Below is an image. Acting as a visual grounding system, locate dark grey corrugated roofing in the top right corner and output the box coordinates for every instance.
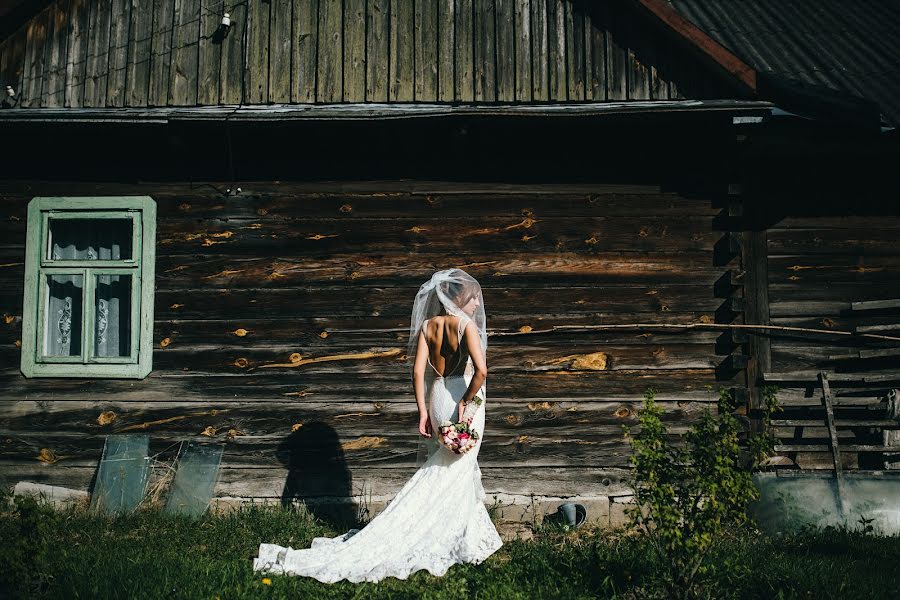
[668,0,900,126]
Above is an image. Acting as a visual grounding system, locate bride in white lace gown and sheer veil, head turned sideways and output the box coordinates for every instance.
[253,269,502,583]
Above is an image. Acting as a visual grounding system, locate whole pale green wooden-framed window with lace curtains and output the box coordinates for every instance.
[22,196,156,378]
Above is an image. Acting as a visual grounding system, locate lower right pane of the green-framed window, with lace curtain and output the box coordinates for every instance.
[94,275,131,357]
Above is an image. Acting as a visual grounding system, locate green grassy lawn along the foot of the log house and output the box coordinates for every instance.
[0,496,900,600]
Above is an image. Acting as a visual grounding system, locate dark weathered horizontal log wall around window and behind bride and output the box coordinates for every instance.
[0,182,732,497]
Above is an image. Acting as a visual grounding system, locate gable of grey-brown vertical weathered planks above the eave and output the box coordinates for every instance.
[0,0,734,108]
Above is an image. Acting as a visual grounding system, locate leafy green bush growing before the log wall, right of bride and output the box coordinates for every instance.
[627,390,776,598]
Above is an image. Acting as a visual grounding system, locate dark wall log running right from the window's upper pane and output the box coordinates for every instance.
[151,217,715,257]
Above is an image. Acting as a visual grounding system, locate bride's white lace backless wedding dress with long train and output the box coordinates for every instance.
[253,320,502,583]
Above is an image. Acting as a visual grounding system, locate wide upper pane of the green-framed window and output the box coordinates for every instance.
[48,219,132,260]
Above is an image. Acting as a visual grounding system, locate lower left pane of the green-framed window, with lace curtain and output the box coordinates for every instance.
[44,275,84,356]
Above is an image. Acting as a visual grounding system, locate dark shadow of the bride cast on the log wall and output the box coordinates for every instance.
[276,421,358,530]
